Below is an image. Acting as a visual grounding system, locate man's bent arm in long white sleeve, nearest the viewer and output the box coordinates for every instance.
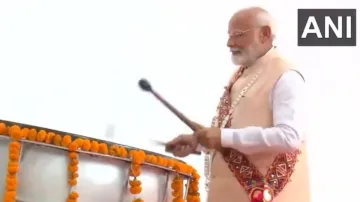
[221,71,305,154]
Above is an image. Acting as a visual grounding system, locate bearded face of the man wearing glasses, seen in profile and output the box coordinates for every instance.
[227,16,261,65]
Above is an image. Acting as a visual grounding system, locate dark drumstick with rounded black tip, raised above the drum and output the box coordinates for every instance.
[139,79,201,155]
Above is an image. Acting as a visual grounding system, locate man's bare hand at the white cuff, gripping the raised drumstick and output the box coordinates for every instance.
[194,127,221,150]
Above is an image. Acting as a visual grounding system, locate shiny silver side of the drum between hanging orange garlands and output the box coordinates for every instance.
[0,121,190,202]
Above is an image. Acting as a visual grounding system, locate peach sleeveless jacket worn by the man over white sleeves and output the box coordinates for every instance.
[208,50,310,202]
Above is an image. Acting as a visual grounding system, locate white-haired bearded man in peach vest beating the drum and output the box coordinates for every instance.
[166,8,310,202]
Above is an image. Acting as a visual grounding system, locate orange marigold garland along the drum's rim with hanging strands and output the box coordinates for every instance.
[0,123,200,202]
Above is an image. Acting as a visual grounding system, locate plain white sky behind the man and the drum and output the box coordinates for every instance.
[0,0,360,202]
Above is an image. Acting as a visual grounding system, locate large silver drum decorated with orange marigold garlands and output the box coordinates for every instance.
[0,120,200,202]
